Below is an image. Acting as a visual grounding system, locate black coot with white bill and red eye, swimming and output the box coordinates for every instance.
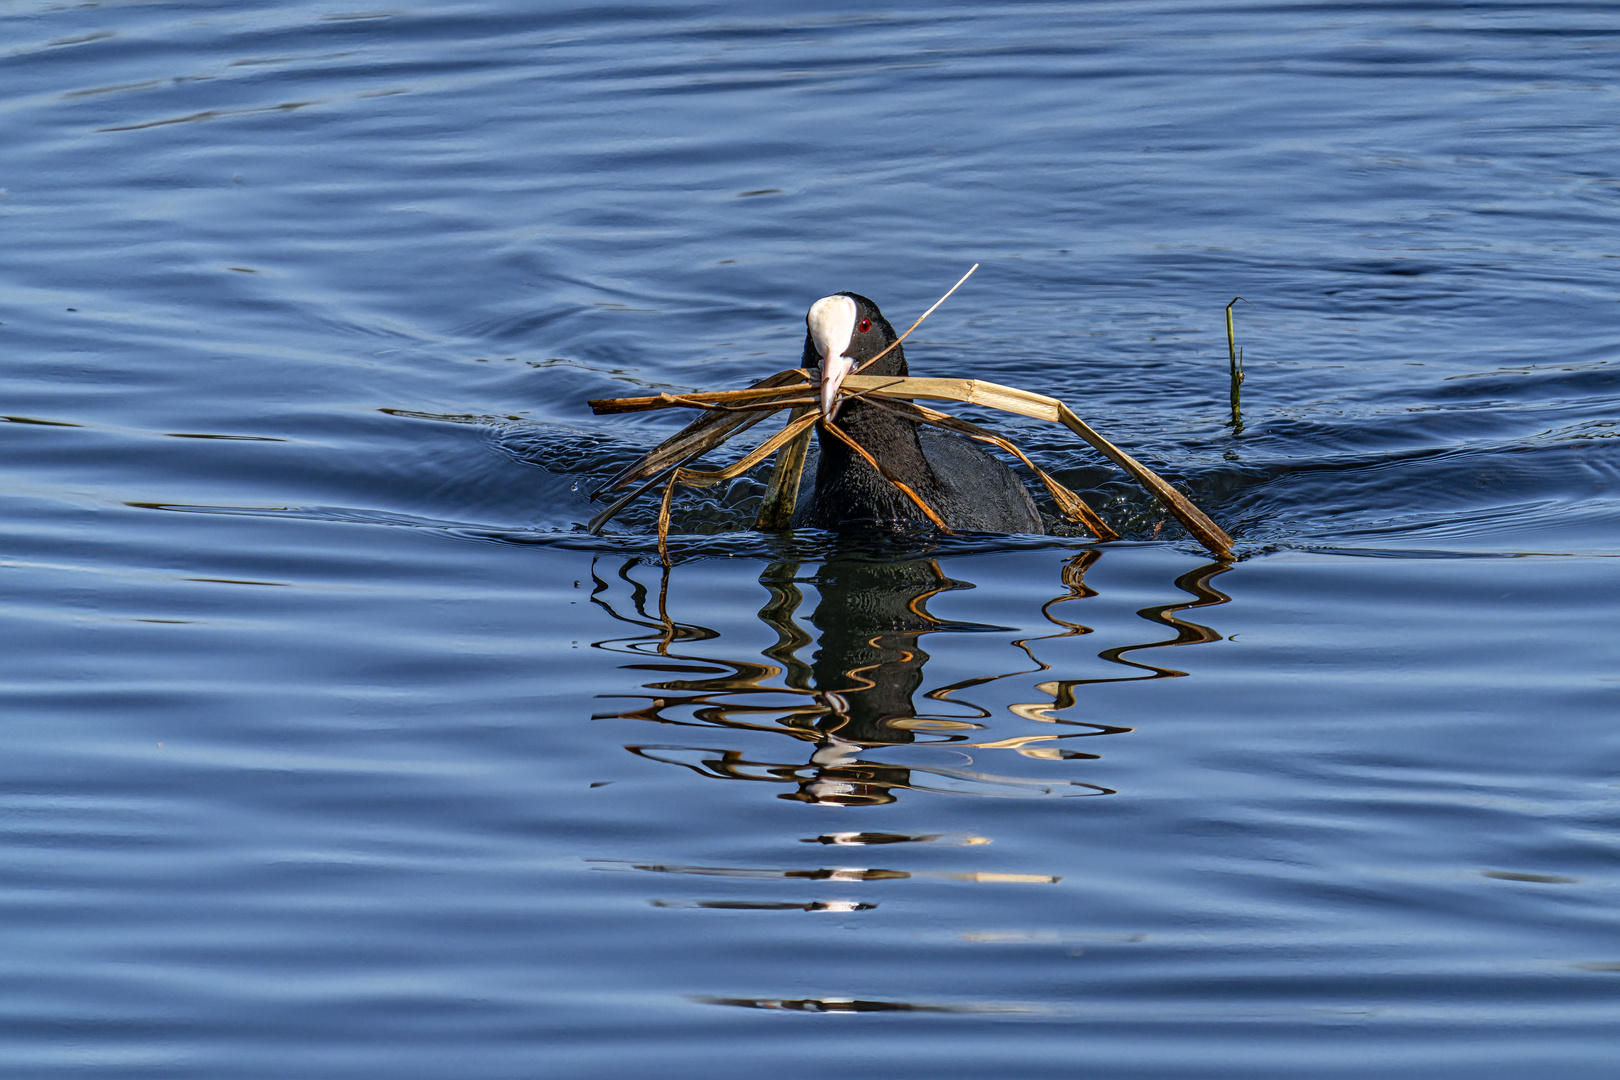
[792,293,1047,533]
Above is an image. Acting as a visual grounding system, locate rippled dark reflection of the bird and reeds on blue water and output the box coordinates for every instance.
[591,549,1230,803]
